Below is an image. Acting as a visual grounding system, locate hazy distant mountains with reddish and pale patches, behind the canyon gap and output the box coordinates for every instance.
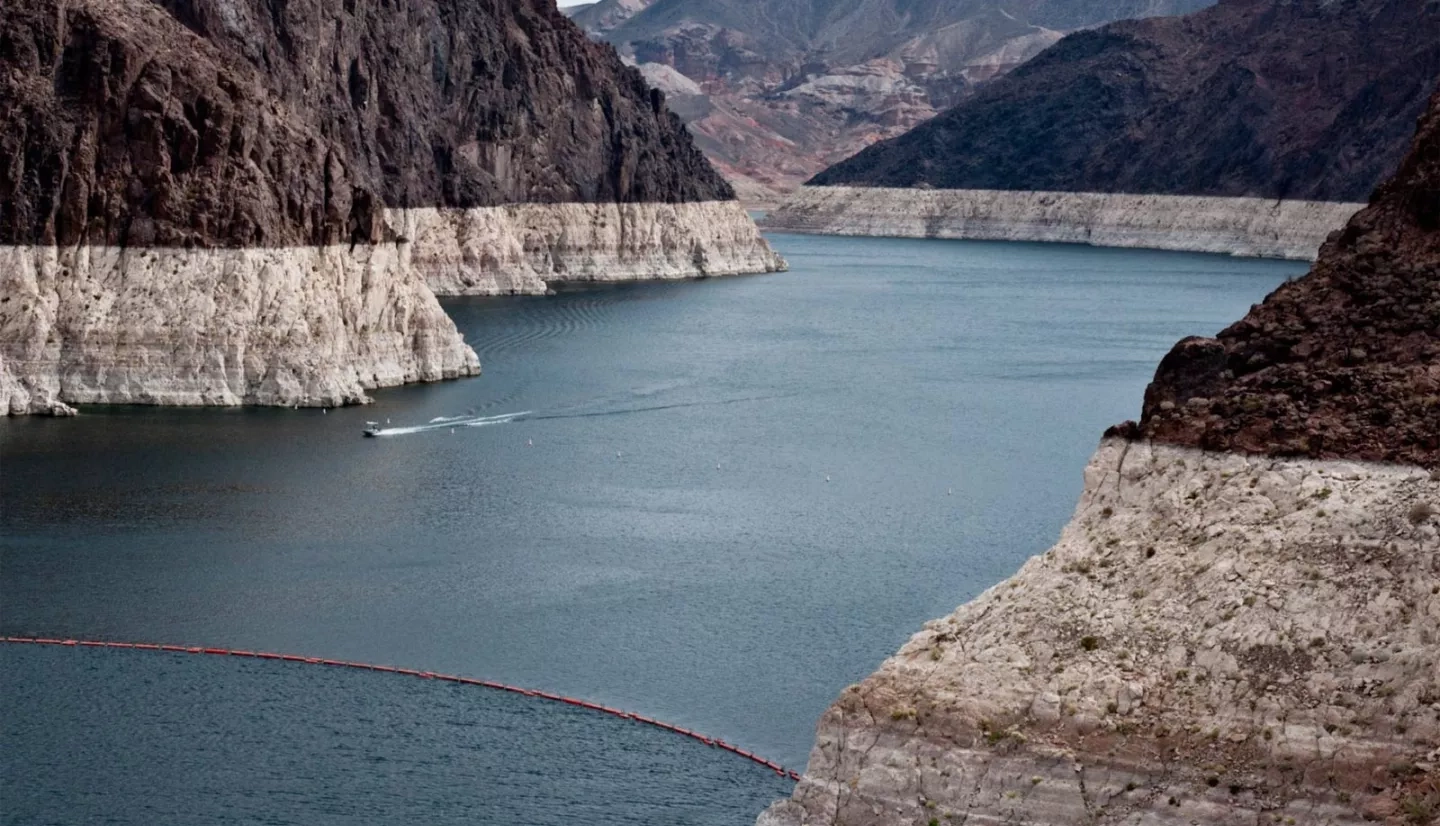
[576,0,1210,201]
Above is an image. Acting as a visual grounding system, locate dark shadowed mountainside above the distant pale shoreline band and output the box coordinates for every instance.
[812,0,1440,201]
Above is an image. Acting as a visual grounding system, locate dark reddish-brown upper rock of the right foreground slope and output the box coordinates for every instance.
[1126,84,1440,468]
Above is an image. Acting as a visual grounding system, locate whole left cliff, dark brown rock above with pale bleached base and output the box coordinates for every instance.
[0,0,783,413]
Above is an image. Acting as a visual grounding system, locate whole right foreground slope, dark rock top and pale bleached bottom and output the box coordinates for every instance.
[760,92,1440,826]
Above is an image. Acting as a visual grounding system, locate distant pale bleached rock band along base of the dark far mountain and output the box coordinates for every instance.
[765,187,1364,260]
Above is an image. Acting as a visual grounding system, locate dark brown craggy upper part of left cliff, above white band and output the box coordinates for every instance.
[0,0,732,246]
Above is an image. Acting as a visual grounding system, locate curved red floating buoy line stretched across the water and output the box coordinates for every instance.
[0,636,801,780]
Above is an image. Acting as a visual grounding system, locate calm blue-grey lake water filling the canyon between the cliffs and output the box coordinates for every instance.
[0,236,1305,825]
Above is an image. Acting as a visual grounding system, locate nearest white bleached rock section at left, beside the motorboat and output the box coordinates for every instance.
[0,245,480,414]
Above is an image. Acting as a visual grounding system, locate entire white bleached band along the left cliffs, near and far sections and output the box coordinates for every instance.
[0,201,785,414]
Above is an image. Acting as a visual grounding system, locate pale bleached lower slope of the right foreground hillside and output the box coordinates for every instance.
[760,439,1440,826]
